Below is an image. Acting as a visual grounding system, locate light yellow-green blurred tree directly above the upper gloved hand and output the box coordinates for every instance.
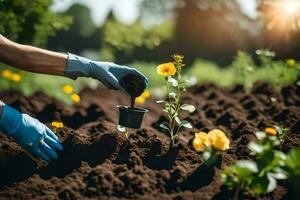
[101,13,174,63]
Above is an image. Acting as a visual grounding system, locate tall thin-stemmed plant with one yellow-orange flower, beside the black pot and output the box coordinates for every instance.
[157,55,195,144]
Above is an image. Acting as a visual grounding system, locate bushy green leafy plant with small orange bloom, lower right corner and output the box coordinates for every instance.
[222,129,287,199]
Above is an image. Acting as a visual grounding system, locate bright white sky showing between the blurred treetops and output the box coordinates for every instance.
[52,0,258,25]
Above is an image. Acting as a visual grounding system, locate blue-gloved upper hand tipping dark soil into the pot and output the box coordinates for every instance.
[65,53,148,95]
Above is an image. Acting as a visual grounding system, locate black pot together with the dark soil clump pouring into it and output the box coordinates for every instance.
[117,74,148,133]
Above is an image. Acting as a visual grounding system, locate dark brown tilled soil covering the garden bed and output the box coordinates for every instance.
[0,84,300,199]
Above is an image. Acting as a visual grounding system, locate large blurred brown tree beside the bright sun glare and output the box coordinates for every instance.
[175,0,260,65]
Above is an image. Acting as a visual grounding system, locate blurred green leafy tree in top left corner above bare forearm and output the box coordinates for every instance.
[0,0,72,45]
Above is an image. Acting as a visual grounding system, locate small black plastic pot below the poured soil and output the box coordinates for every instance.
[117,105,148,129]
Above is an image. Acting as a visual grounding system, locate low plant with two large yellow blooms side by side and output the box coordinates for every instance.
[193,129,230,165]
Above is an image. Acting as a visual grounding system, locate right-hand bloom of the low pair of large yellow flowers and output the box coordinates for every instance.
[208,129,230,151]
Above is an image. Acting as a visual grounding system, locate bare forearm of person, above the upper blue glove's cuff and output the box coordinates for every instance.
[0,35,68,76]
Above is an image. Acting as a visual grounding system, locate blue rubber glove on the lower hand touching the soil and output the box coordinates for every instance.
[0,105,63,160]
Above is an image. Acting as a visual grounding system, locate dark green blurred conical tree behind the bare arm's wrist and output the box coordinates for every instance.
[48,4,102,54]
